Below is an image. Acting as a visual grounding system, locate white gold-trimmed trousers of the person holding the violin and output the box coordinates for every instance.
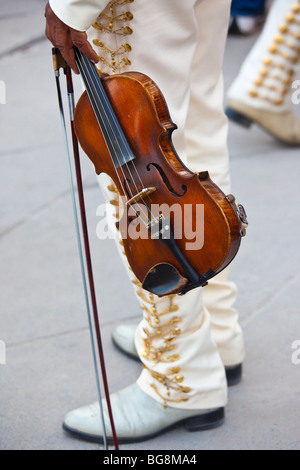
[85,0,244,409]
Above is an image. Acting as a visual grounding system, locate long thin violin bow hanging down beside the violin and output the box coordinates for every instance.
[52,48,119,450]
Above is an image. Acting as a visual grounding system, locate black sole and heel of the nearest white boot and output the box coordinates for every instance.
[62,408,225,445]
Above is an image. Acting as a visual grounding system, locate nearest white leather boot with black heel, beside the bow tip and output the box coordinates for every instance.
[63,384,225,444]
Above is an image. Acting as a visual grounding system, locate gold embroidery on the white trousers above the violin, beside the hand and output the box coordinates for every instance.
[93,0,134,74]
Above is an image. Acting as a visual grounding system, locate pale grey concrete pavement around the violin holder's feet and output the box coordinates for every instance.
[0,0,300,450]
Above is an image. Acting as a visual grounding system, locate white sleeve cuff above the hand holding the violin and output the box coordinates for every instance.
[49,0,108,31]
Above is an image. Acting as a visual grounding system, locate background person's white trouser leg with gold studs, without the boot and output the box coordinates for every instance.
[228,0,300,112]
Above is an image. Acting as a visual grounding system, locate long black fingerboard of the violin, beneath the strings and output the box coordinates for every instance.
[74,47,135,169]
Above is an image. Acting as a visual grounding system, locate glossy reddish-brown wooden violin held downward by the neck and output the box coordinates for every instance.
[74,48,248,297]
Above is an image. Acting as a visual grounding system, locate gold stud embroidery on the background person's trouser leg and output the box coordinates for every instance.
[249,0,300,106]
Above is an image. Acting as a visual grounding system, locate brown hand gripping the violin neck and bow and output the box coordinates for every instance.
[45,2,99,74]
